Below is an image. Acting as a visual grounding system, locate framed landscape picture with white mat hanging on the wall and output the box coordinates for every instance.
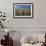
[13,3,33,17]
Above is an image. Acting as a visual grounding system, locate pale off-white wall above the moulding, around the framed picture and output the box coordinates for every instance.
[0,0,46,27]
